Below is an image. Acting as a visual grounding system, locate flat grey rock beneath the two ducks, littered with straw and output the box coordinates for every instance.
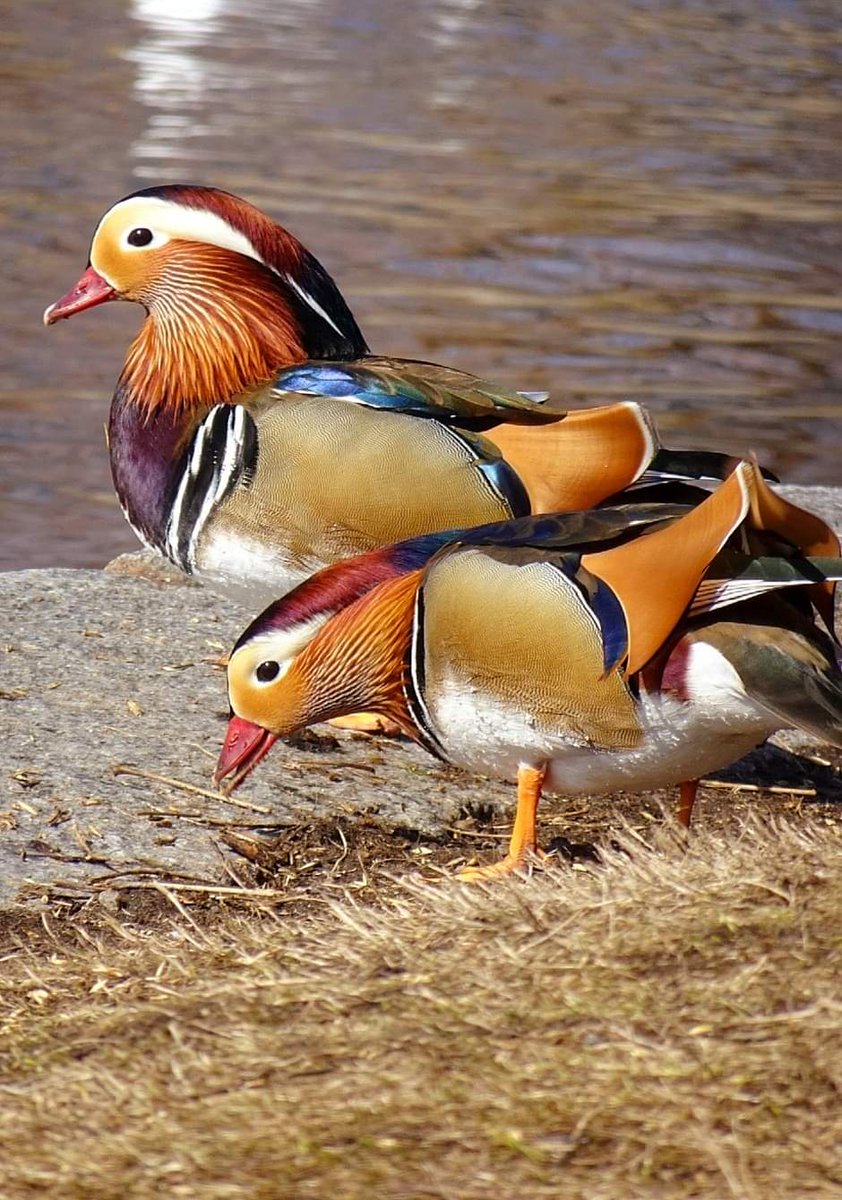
[0,488,842,906]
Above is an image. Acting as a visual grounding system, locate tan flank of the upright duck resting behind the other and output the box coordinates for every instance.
[206,392,529,570]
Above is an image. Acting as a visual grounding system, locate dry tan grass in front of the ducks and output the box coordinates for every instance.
[0,823,842,1200]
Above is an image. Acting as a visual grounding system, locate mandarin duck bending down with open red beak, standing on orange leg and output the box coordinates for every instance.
[215,463,842,880]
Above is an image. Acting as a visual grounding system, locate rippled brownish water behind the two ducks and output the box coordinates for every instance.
[0,0,842,566]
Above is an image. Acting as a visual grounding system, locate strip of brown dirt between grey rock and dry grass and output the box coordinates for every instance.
[0,738,842,950]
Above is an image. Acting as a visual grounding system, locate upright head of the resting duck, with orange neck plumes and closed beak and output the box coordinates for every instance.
[43,184,368,408]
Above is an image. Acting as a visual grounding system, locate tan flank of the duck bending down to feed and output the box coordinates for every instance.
[415,545,642,757]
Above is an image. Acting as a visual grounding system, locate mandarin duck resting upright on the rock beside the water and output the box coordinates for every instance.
[44,185,743,604]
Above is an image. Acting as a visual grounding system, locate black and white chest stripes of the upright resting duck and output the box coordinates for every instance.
[163,404,258,574]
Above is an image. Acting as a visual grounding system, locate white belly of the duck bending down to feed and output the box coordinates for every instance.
[427,643,781,797]
